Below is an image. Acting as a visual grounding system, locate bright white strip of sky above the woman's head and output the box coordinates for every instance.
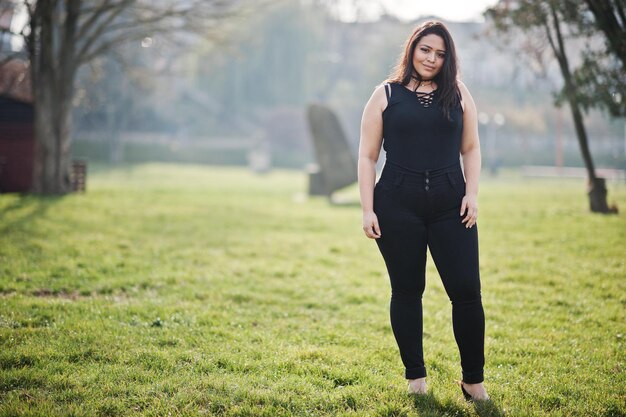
[337,0,497,21]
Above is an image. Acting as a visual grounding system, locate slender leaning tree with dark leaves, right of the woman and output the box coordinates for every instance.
[485,0,626,213]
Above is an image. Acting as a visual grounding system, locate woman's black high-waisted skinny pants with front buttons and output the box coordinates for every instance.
[374,163,485,384]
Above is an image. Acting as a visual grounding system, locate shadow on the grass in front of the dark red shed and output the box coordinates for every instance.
[0,194,64,234]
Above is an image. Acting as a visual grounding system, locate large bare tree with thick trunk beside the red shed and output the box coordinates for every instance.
[2,0,265,194]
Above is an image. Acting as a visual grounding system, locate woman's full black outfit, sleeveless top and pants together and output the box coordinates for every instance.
[374,84,485,383]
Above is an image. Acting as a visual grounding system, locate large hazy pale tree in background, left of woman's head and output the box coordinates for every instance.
[185,0,400,156]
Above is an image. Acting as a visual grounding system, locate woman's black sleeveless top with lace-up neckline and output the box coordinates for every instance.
[383,83,463,171]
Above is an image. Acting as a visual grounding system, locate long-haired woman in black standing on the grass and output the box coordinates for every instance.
[358,21,489,400]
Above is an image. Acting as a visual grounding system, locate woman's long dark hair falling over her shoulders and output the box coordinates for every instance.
[385,20,461,119]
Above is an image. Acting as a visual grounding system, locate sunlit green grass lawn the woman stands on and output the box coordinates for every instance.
[0,164,626,417]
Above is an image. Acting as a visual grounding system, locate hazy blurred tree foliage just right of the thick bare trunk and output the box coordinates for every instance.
[72,36,176,164]
